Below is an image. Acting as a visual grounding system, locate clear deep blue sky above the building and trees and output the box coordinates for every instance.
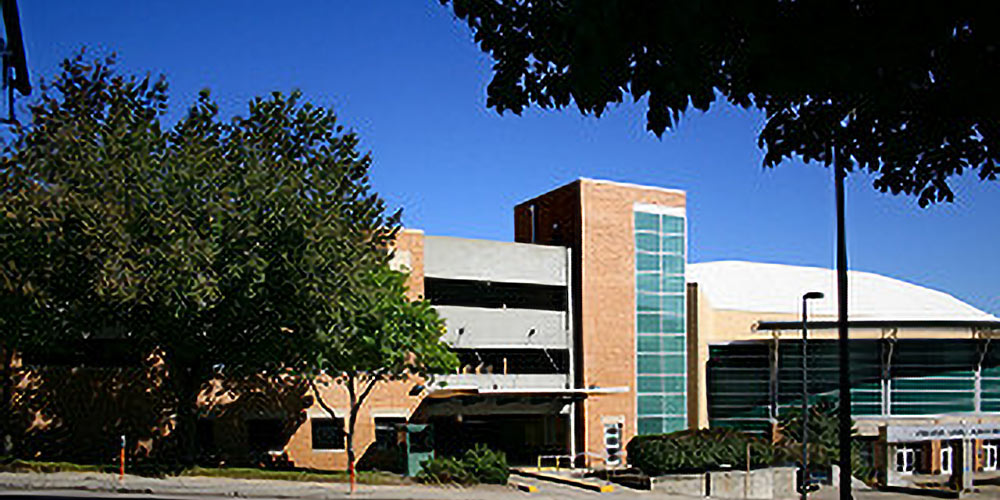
[20,0,1000,315]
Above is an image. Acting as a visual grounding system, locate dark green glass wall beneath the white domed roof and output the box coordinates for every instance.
[708,339,1000,432]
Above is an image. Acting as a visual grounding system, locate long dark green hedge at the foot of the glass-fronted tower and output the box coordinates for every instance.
[626,429,783,476]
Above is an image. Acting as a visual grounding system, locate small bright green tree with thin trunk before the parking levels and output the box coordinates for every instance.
[304,266,458,491]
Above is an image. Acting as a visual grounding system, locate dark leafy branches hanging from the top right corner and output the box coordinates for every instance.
[441,0,1000,206]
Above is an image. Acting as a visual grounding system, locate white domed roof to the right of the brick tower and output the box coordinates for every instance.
[687,261,1000,321]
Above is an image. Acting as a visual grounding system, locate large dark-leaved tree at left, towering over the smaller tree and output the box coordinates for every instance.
[0,53,399,463]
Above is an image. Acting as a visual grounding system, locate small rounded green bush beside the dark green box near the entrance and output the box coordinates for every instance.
[417,445,510,485]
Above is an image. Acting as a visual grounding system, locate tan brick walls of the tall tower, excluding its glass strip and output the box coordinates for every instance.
[514,179,685,464]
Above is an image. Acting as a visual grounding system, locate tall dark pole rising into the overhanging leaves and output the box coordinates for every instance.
[833,154,853,500]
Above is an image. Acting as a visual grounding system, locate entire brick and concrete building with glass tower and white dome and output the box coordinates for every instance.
[11,179,1000,472]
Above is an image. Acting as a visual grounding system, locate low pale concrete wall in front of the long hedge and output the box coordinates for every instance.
[651,467,798,500]
